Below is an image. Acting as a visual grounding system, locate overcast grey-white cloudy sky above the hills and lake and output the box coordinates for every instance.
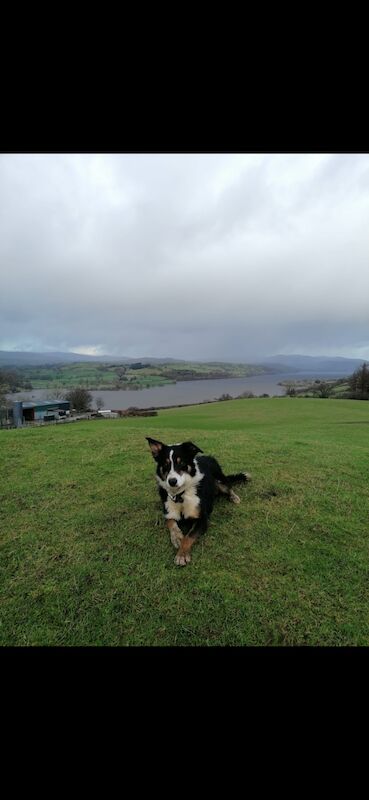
[0,154,369,361]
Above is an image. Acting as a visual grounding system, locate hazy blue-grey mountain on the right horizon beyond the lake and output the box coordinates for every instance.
[261,355,364,375]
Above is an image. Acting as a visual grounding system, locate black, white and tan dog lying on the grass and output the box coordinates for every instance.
[146,436,251,567]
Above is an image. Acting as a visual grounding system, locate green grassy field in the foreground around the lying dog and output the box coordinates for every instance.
[0,398,369,646]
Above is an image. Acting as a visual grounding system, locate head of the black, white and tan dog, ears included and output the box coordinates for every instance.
[146,436,203,495]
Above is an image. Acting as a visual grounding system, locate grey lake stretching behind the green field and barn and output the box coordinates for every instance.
[8,372,346,409]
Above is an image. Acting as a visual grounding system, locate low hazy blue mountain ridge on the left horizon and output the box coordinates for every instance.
[0,350,183,367]
